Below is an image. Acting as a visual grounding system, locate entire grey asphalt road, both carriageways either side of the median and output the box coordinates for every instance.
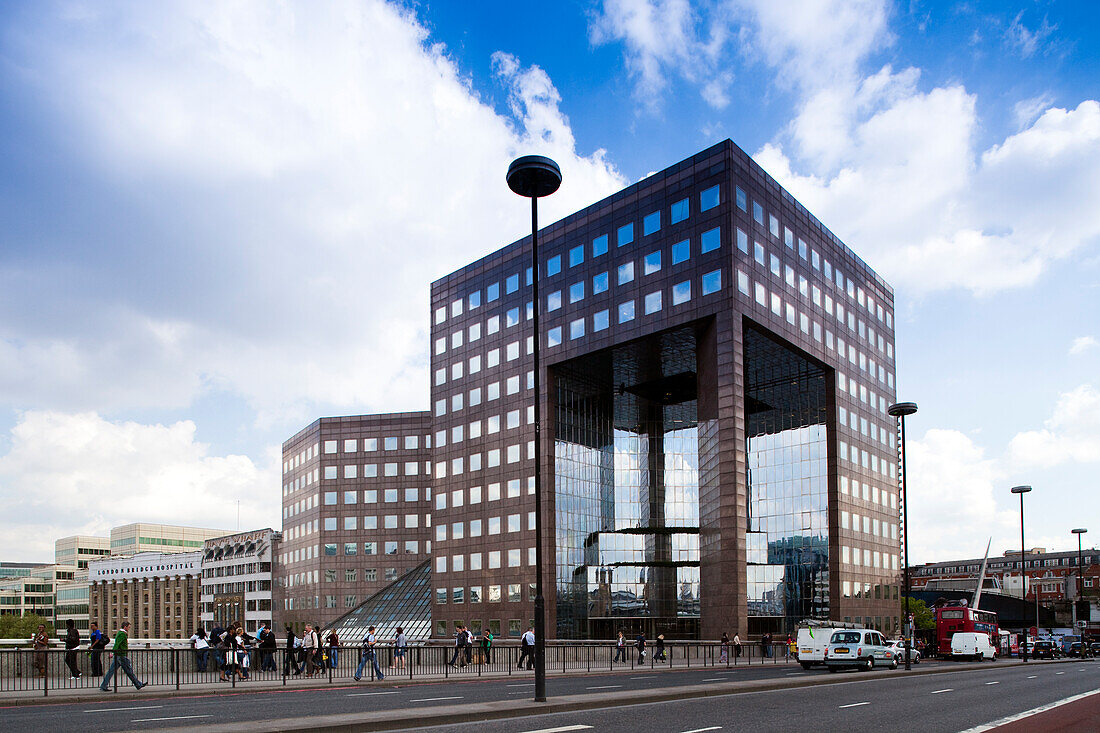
[0,661,1100,733]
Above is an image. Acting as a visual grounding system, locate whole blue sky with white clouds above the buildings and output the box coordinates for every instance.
[0,0,1100,561]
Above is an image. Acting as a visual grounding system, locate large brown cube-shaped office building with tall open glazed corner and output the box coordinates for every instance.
[430,141,901,638]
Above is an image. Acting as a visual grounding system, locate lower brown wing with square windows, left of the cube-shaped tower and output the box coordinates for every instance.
[276,413,431,627]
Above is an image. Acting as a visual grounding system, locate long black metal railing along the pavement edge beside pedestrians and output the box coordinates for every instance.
[0,642,795,696]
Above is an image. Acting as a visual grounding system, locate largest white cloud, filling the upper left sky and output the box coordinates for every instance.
[0,0,625,424]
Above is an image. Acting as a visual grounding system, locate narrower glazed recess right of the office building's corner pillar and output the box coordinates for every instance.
[745,324,829,634]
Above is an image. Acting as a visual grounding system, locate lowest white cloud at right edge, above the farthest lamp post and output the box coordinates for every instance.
[1009,384,1100,468]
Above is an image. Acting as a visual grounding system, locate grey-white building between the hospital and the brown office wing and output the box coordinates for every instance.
[201,529,283,634]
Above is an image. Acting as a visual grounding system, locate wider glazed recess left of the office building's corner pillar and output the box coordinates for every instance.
[553,328,700,638]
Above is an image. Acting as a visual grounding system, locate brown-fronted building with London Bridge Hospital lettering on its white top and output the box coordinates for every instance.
[88,548,202,638]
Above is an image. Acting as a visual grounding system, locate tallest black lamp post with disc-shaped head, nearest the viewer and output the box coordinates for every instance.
[507,150,561,702]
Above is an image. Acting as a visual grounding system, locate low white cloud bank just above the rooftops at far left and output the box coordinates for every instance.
[0,412,281,561]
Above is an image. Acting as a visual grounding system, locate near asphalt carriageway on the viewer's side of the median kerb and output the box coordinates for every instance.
[422,661,1100,733]
